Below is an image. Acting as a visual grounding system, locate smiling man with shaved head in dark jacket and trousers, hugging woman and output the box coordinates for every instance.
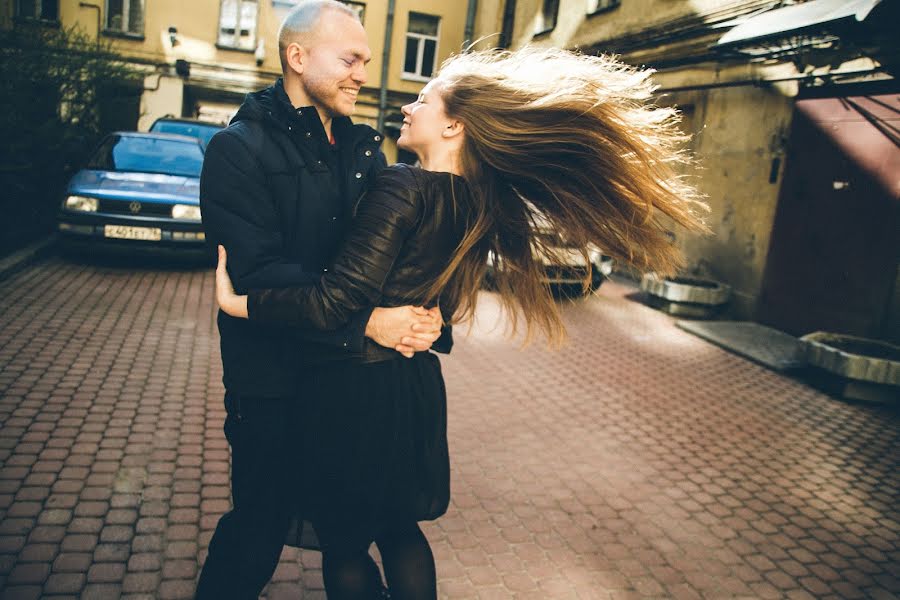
[197,0,449,600]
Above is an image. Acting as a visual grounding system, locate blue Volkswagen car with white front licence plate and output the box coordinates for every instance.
[57,132,206,251]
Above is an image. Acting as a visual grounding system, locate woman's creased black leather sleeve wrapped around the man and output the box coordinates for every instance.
[247,166,422,330]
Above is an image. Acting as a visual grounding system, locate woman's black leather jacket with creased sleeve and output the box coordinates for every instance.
[248,164,470,362]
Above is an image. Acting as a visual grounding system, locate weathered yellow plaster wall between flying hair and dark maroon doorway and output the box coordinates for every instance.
[656,73,793,317]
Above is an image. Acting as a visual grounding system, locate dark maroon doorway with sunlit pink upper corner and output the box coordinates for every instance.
[757,94,900,340]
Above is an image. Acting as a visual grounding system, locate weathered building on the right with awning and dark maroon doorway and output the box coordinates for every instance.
[475,0,900,340]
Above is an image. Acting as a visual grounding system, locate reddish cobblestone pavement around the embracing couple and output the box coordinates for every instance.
[0,259,900,599]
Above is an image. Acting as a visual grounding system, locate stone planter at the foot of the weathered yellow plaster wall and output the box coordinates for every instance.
[641,273,731,319]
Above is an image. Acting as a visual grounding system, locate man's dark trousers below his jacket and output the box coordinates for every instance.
[196,393,302,600]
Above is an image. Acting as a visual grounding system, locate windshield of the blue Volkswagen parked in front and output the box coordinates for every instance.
[88,135,203,177]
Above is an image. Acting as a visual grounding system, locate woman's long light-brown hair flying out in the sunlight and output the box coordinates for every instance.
[426,48,706,342]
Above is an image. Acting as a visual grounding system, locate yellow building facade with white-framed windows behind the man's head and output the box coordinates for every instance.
[0,0,467,160]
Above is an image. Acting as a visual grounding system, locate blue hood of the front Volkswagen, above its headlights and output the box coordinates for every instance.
[68,169,200,204]
